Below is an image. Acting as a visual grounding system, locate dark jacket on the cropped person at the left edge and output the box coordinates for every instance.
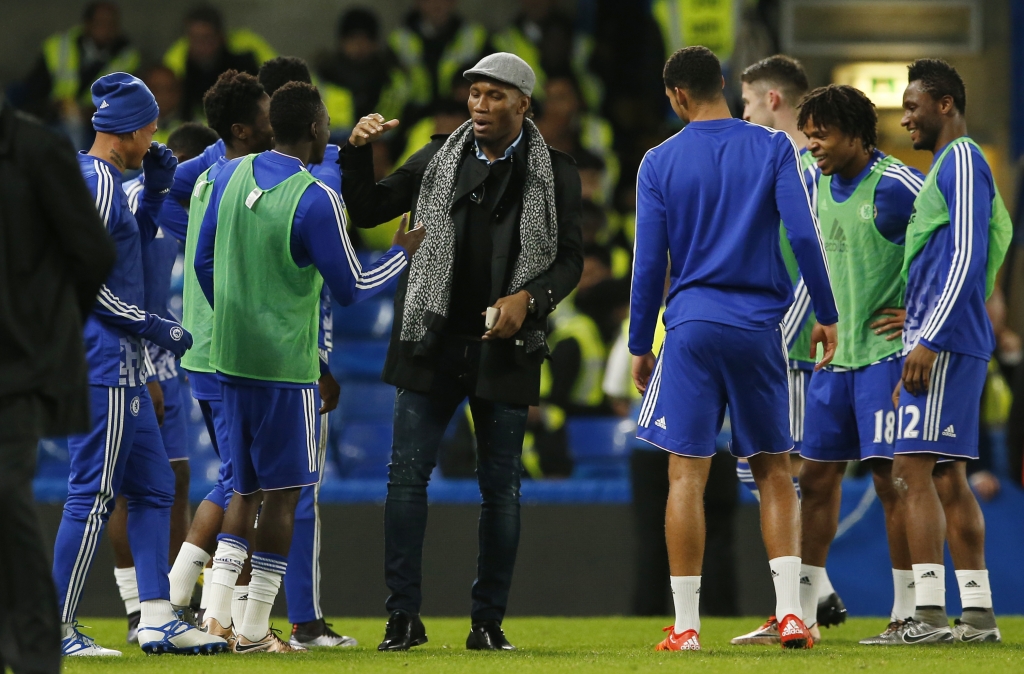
[0,101,120,435]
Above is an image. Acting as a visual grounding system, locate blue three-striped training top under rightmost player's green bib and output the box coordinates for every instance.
[903,142,995,361]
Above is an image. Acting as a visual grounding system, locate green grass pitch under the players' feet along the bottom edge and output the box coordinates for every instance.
[63,617,1024,674]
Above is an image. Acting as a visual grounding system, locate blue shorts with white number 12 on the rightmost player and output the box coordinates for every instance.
[896,351,988,459]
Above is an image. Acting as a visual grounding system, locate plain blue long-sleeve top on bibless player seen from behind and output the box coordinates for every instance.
[630,119,839,355]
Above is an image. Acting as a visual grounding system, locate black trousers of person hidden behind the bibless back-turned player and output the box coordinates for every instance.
[630,450,738,616]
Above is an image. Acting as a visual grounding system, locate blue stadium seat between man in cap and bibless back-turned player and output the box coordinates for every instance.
[566,417,636,479]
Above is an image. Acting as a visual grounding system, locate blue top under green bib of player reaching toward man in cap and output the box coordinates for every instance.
[195,151,409,381]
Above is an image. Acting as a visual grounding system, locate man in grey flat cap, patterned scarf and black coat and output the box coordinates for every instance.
[339,53,583,650]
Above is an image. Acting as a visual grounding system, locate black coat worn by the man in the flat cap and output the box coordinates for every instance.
[338,129,583,405]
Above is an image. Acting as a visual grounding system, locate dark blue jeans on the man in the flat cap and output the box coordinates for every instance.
[384,338,527,622]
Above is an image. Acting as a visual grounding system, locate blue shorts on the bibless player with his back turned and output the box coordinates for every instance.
[637,321,793,458]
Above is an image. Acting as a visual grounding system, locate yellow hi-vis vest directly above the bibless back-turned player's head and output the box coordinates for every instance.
[650,0,737,61]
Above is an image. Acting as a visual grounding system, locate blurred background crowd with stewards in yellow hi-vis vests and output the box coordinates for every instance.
[7,0,1020,493]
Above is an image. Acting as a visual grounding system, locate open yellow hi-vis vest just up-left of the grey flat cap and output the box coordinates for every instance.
[388,22,487,104]
